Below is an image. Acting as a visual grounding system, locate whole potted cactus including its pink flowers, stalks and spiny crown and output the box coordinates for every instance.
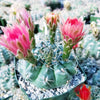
[0,9,84,92]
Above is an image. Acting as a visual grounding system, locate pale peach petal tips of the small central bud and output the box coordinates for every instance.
[45,12,59,25]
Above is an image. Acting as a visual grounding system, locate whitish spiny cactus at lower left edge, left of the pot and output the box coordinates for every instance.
[0,62,18,91]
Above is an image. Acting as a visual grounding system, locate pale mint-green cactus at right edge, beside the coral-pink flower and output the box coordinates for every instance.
[81,34,100,59]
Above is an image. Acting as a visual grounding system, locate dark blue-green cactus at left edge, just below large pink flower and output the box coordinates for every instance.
[0,46,13,66]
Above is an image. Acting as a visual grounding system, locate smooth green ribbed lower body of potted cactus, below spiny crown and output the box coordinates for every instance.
[18,60,76,89]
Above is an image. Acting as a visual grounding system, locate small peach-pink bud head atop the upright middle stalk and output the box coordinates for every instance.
[45,12,59,29]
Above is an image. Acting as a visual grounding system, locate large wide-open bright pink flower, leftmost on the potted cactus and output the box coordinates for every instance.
[0,23,31,57]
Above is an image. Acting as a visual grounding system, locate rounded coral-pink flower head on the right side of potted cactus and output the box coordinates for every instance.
[61,18,84,44]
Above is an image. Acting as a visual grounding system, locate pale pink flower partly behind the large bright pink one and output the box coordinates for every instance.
[16,8,34,32]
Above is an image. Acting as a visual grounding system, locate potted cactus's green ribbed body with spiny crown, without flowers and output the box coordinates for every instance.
[17,41,77,89]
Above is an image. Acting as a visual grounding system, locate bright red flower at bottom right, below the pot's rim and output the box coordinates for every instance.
[76,84,91,100]
